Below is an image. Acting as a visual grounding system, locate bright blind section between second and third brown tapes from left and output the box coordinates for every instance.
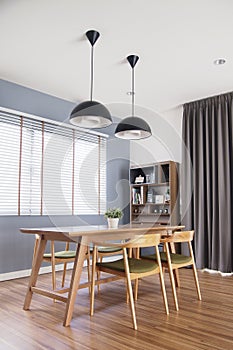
[42,123,73,215]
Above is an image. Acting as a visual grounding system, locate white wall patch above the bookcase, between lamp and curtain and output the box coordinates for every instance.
[130,106,183,165]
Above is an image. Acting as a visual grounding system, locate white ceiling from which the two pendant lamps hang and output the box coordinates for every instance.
[0,0,233,117]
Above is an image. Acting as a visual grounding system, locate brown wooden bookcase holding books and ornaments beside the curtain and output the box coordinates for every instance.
[130,161,180,225]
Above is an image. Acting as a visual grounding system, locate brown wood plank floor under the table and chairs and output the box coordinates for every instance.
[0,269,233,350]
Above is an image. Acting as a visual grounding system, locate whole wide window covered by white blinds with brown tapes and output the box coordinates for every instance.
[0,112,106,215]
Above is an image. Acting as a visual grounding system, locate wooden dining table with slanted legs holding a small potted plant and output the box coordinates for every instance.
[20,224,184,326]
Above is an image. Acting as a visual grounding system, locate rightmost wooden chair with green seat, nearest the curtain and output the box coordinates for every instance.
[141,231,201,311]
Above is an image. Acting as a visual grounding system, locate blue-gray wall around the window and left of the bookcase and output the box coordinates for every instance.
[0,80,130,274]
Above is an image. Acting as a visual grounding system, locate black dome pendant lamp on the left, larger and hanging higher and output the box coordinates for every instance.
[70,30,112,129]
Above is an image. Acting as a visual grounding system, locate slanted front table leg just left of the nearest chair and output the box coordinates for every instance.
[63,240,87,327]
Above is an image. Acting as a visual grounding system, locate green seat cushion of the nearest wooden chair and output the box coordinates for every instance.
[96,258,158,273]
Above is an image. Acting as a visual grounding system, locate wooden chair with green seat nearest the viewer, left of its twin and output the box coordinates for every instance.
[90,234,169,330]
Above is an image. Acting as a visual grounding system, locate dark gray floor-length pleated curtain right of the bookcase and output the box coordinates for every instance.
[181,93,233,272]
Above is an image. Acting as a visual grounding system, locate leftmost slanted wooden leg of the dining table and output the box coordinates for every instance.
[23,237,47,310]
